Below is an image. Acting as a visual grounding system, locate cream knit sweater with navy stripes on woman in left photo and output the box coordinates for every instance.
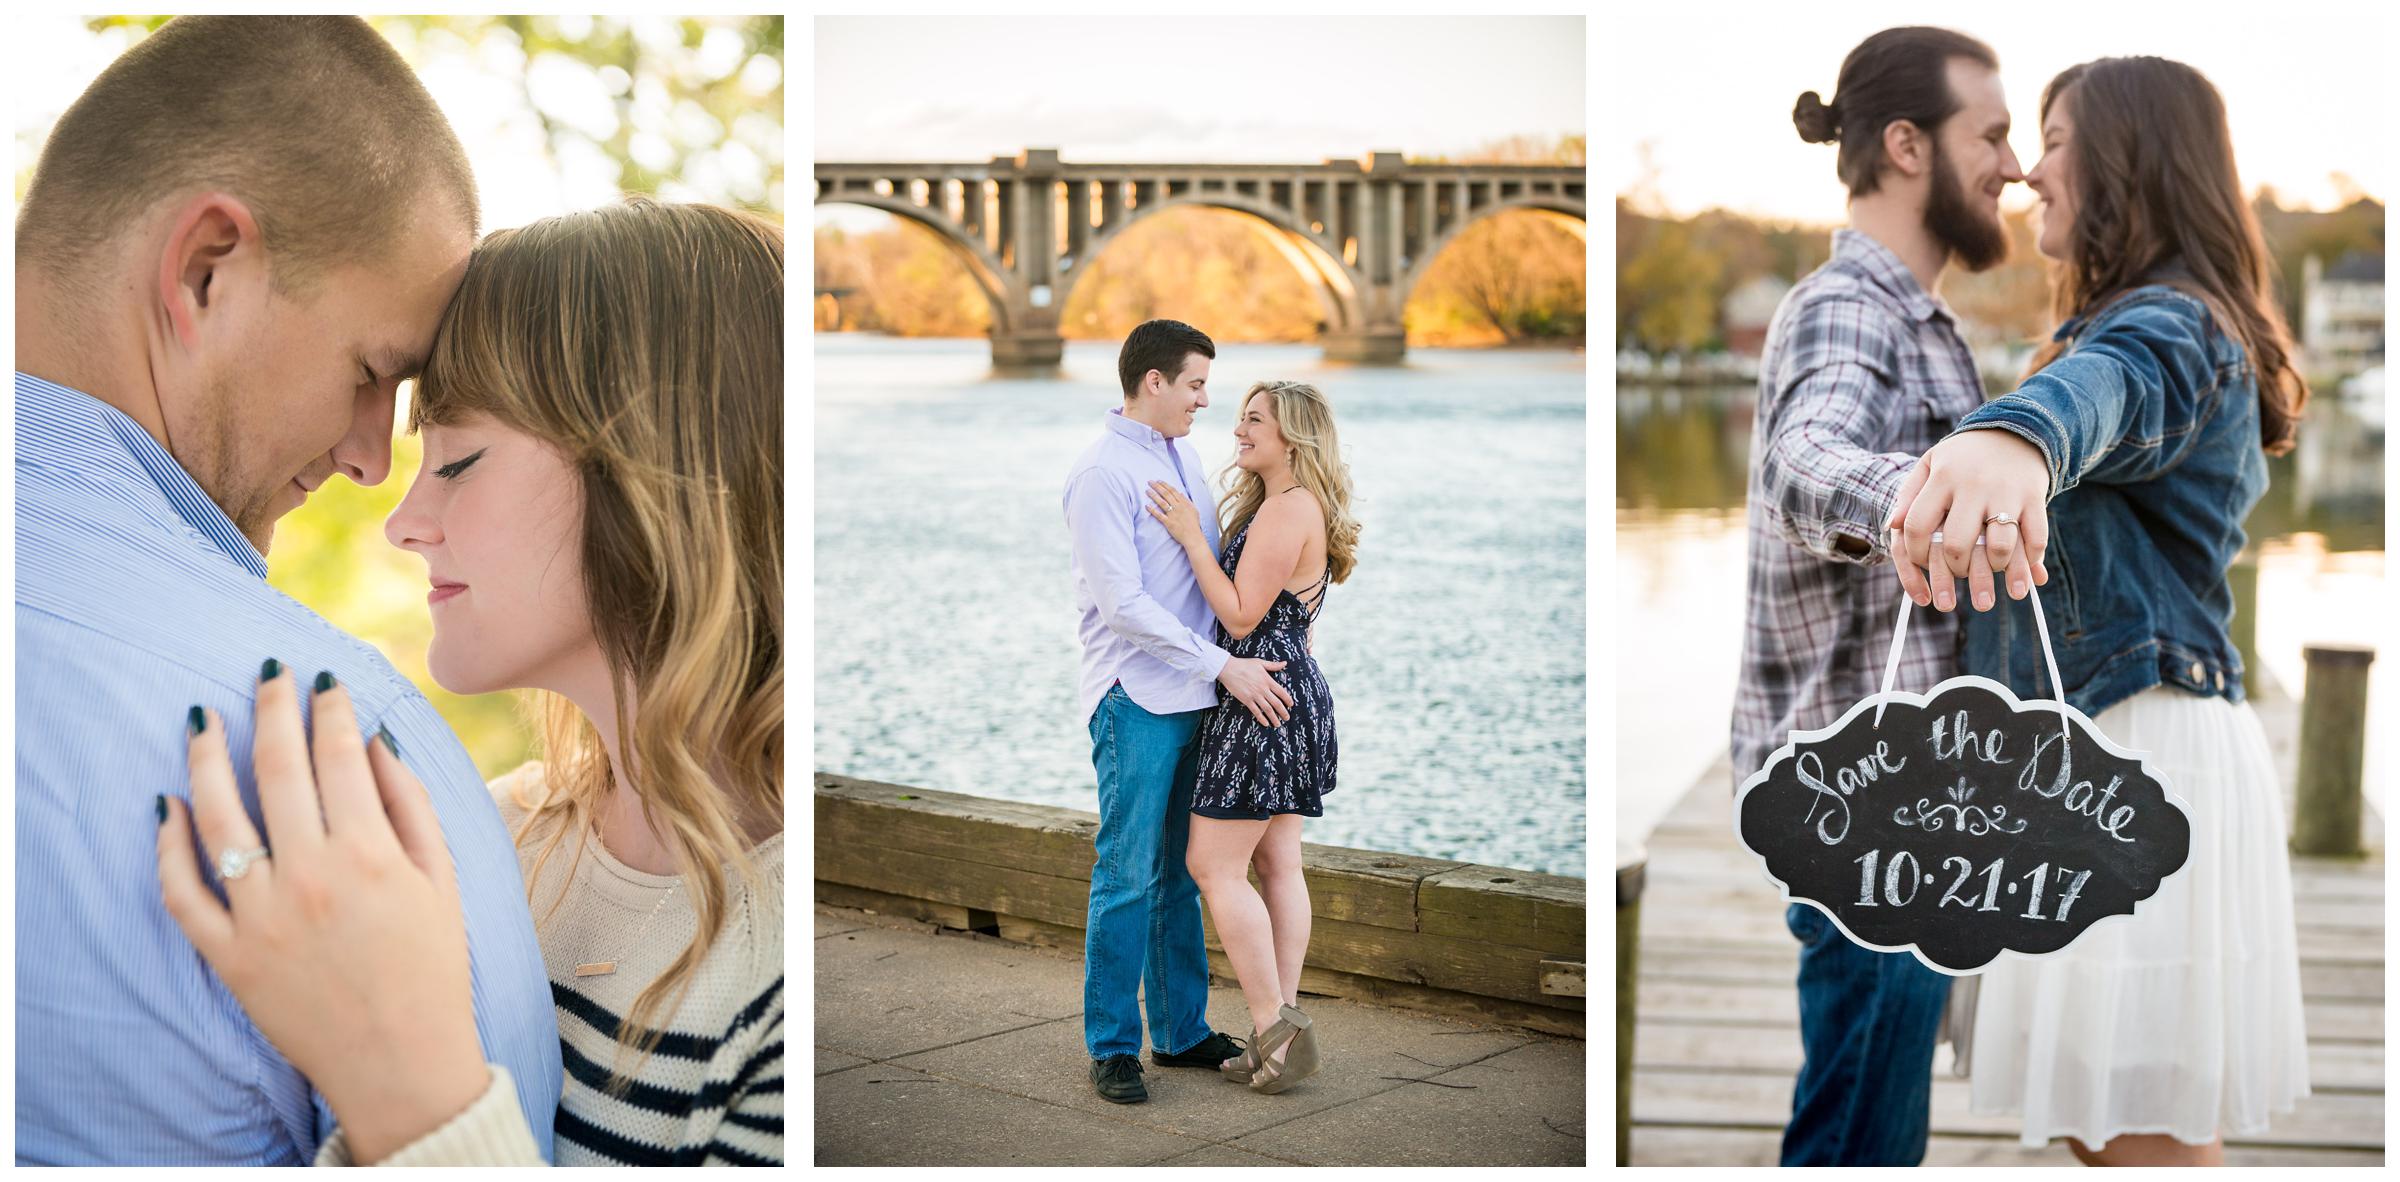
[317,764,785,1165]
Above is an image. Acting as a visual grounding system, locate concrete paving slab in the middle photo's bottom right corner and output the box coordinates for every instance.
[1234,1038,1586,1165]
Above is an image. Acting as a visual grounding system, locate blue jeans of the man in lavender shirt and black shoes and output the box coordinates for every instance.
[1082,685,1210,1059]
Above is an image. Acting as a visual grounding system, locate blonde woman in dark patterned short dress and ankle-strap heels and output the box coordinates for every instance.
[1150,382,1358,1093]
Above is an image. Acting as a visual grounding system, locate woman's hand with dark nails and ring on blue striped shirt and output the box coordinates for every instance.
[158,670,490,1160]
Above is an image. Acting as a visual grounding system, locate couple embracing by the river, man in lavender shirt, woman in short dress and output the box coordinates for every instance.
[1063,320,1358,1103]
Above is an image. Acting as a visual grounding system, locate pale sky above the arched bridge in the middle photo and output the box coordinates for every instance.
[816,17,1584,163]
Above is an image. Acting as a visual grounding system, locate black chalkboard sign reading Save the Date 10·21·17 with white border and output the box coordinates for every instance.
[1735,677,2191,975]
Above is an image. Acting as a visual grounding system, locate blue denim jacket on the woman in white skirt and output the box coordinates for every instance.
[1958,283,2266,716]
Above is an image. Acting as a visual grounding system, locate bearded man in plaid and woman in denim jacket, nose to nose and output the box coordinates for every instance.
[1733,29,2309,1165]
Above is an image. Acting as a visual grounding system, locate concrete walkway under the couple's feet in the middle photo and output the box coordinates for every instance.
[816,906,1584,1165]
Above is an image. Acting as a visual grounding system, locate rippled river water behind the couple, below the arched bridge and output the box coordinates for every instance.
[814,334,1586,877]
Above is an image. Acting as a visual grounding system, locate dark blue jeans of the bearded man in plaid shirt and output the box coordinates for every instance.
[1783,903,1949,1165]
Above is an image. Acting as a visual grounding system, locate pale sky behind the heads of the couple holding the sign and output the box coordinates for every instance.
[1594,0,2393,223]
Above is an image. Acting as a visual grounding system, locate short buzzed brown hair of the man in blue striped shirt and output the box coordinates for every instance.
[17,17,478,293]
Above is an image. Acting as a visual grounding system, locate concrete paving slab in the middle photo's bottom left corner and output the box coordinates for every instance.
[816,1064,1207,1165]
